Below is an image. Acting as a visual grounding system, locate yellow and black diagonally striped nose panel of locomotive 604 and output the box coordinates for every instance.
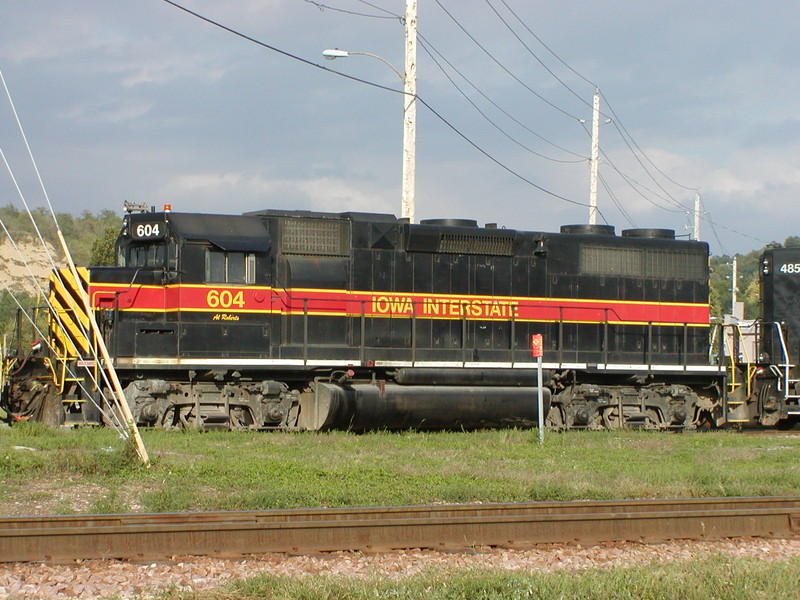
[49,267,91,358]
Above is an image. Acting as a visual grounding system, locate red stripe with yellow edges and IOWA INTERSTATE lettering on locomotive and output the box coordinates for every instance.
[90,284,709,325]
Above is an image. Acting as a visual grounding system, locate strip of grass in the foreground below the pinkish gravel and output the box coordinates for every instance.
[152,556,800,600]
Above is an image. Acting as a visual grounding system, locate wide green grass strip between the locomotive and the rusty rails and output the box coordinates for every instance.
[0,424,800,514]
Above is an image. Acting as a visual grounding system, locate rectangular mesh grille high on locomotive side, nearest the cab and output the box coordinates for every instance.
[281,219,350,256]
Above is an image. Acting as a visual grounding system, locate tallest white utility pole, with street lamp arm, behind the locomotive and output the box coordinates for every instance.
[402,0,417,223]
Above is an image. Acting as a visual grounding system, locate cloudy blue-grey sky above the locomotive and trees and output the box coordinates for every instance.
[0,0,800,254]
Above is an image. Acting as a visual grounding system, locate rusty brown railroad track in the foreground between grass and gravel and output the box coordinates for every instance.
[0,496,800,562]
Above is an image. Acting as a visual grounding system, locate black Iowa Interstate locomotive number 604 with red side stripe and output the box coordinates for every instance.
[2,210,800,430]
